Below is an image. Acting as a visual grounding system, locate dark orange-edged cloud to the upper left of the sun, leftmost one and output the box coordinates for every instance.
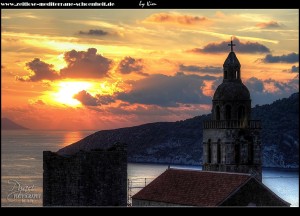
[16,58,59,82]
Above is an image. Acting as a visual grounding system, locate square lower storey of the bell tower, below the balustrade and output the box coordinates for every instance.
[202,128,262,181]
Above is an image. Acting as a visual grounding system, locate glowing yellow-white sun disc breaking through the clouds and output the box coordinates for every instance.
[52,81,92,106]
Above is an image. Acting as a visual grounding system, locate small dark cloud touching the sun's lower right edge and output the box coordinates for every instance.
[73,90,115,106]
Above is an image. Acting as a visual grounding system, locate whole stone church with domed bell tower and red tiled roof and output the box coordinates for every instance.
[132,41,290,207]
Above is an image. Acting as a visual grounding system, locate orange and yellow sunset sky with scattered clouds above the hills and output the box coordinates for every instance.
[1,9,299,130]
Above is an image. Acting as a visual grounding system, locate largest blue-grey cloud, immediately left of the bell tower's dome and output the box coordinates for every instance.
[117,73,211,107]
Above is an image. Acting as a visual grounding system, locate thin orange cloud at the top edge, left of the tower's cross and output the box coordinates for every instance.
[144,13,207,25]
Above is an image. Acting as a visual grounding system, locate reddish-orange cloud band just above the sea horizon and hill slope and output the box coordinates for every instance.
[2,100,211,130]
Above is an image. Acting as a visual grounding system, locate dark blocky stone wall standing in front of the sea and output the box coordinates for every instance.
[43,144,127,206]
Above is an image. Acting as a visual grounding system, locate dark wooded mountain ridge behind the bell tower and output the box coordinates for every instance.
[58,92,299,168]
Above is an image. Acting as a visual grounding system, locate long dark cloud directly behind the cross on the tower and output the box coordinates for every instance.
[188,38,270,53]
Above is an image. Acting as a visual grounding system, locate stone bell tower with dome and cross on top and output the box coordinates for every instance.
[203,40,262,181]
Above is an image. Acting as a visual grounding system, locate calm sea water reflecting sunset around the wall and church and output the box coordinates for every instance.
[1,131,299,207]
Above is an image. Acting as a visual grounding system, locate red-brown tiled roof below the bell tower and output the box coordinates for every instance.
[132,169,251,206]
